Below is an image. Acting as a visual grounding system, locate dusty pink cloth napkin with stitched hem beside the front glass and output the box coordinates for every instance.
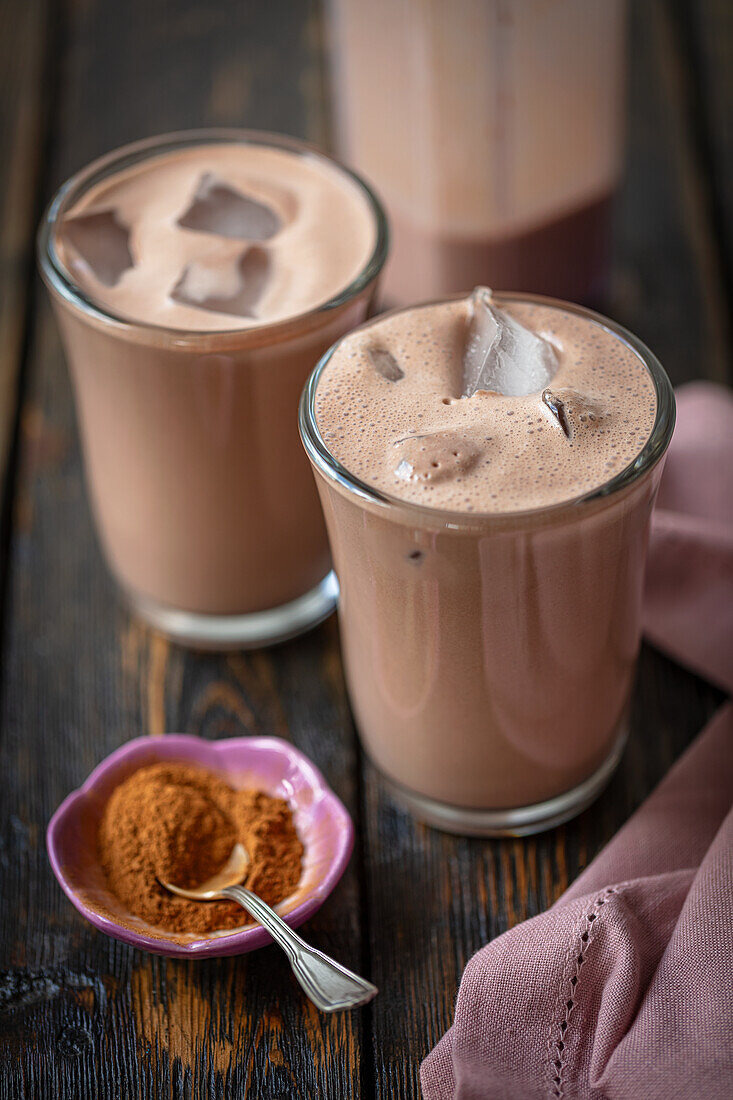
[422,383,733,1100]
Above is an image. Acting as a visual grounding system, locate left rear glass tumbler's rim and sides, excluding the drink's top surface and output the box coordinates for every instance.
[39,130,386,648]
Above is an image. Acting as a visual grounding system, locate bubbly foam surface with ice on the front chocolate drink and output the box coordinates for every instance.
[316,288,656,513]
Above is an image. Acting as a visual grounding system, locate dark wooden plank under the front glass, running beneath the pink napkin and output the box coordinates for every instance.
[363,2,726,1100]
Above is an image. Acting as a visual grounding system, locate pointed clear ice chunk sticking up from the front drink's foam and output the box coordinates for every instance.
[461,286,558,397]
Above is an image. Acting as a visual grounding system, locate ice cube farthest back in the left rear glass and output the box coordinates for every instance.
[177,172,283,241]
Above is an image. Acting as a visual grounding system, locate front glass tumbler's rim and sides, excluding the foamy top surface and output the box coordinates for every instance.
[300,295,675,836]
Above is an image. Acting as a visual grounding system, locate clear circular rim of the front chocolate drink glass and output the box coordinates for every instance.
[298,292,676,528]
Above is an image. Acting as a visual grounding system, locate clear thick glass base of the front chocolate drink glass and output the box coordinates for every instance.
[381,722,628,836]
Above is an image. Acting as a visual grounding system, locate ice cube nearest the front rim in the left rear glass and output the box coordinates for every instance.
[171,244,271,318]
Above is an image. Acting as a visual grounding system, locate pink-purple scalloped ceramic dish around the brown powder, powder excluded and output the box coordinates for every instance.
[46,734,353,958]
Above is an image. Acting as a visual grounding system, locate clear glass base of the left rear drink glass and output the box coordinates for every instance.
[127,570,339,649]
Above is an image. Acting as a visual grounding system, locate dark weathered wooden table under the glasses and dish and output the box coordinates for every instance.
[0,0,733,1100]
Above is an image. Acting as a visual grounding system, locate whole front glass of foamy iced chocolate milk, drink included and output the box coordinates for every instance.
[300,287,675,835]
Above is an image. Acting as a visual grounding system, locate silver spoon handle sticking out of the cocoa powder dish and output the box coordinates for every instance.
[221,887,378,1012]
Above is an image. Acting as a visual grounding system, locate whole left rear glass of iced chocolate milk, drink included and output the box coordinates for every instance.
[39,130,386,648]
